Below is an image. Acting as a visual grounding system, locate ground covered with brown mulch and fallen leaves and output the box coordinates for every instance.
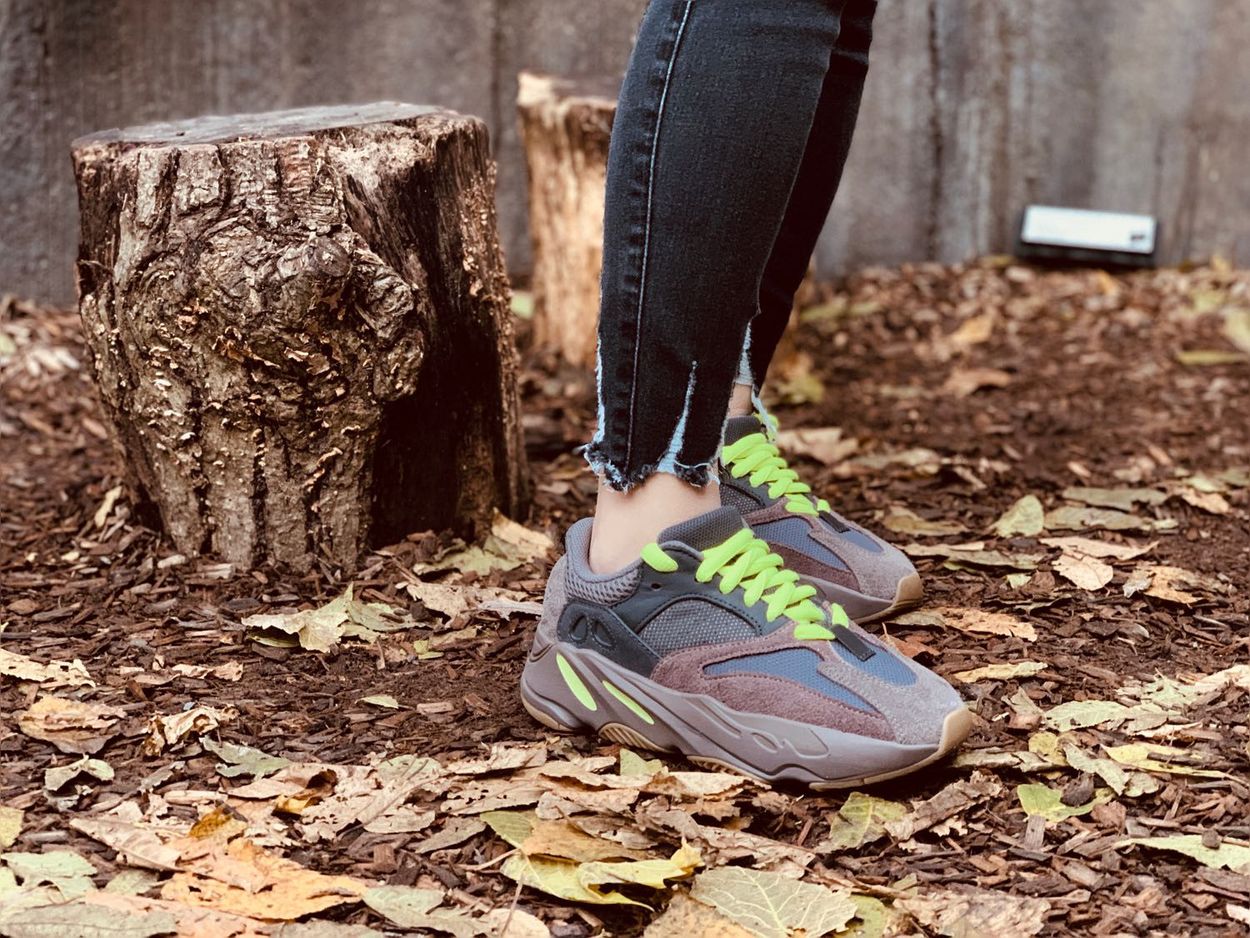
[0,258,1250,938]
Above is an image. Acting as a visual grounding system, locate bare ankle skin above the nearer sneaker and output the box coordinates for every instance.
[590,473,720,573]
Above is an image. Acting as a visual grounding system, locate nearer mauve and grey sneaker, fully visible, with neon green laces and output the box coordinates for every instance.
[521,508,973,788]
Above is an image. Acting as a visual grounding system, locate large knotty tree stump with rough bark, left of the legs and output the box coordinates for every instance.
[74,103,526,572]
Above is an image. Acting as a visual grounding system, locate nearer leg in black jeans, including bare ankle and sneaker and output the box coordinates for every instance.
[521,0,971,787]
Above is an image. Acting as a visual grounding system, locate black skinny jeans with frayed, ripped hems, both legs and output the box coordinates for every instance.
[586,0,876,490]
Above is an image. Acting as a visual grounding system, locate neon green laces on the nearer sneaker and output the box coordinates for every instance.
[643,528,830,627]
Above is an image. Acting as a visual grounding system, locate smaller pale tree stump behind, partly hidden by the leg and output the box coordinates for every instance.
[516,71,620,368]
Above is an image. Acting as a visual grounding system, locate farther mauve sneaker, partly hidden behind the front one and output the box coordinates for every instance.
[720,415,924,624]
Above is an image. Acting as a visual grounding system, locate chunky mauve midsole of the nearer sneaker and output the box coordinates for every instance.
[521,642,940,783]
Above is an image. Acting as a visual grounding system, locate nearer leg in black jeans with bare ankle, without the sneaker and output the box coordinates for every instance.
[588,0,839,570]
